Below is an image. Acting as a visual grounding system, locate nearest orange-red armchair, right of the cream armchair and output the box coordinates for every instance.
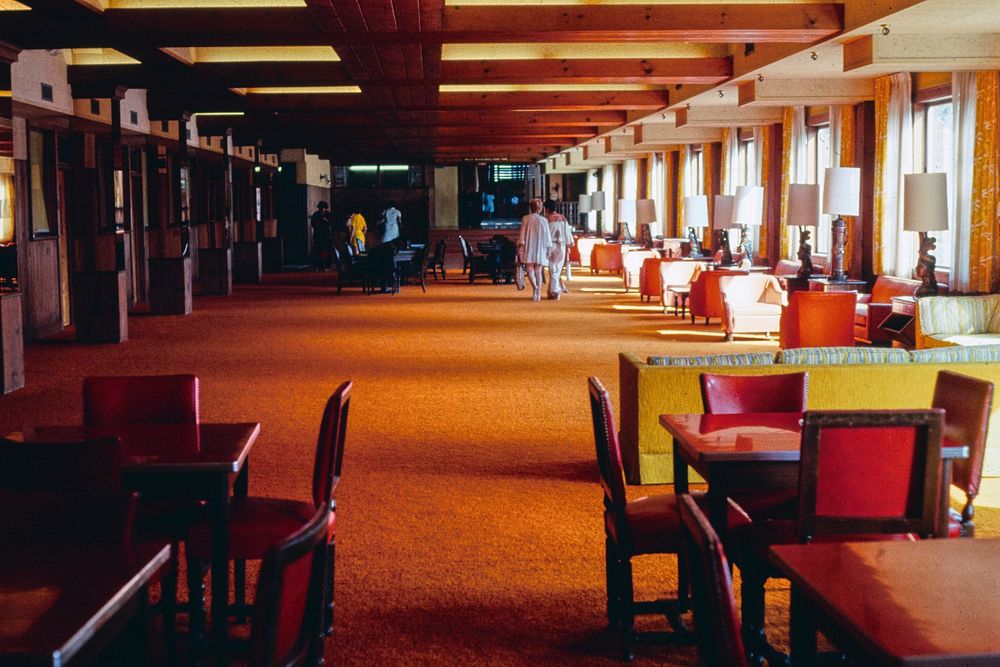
[781,291,858,349]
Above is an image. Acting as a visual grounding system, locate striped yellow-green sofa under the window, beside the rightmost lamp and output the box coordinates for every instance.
[915,294,1000,349]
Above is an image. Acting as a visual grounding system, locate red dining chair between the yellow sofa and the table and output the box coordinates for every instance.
[698,372,809,521]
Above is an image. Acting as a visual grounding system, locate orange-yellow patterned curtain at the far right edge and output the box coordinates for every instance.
[969,72,1000,292]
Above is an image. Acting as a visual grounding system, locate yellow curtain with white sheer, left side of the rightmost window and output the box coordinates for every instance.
[874,72,917,278]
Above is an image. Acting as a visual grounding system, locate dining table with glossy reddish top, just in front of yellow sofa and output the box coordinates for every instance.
[660,412,969,545]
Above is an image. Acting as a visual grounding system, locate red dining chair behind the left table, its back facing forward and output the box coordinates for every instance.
[83,374,204,642]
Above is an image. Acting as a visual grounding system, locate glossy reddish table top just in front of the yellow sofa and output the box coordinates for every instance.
[660,412,969,463]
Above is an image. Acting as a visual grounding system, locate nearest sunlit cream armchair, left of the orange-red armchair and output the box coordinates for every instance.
[719,273,788,340]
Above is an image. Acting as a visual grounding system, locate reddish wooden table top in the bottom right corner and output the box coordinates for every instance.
[770,539,1000,665]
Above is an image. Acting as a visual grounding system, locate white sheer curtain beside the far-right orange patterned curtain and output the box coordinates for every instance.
[948,72,976,292]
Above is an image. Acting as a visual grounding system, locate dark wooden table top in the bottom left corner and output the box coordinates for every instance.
[0,544,170,665]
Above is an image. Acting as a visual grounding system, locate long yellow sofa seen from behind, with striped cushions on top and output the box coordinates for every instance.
[618,345,1000,484]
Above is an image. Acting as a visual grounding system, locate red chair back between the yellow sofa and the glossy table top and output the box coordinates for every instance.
[699,372,809,415]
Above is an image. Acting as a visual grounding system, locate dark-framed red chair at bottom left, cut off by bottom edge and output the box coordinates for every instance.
[250,507,330,667]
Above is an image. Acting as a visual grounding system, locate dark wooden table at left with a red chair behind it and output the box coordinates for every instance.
[15,422,260,656]
